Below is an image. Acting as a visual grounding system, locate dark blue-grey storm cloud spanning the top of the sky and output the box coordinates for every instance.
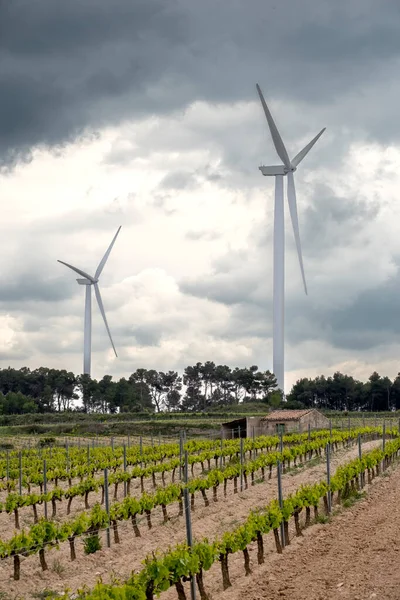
[0,0,400,163]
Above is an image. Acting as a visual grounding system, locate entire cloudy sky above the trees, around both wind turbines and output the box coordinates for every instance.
[0,0,400,388]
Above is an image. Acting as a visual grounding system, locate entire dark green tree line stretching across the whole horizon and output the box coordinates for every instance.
[0,361,400,414]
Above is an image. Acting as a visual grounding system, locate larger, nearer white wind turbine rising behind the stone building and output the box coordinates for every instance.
[257,84,325,392]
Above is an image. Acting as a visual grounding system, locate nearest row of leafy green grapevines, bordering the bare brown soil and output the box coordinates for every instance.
[66,438,400,600]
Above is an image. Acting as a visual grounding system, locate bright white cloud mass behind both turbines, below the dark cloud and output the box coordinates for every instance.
[0,96,400,394]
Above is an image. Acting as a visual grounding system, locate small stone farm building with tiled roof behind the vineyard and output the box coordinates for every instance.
[221,408,329,439]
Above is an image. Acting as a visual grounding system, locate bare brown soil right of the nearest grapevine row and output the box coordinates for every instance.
[220,458,400,600]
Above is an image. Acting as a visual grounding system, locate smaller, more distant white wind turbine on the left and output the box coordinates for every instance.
[58,226,121,375]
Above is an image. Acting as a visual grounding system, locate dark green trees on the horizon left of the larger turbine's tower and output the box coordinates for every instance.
[0,361,276,414]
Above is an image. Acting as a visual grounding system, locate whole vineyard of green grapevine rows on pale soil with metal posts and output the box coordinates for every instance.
[0,427,400,600]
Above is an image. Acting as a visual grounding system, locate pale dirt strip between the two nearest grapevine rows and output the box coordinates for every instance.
[0,440,382,599]
